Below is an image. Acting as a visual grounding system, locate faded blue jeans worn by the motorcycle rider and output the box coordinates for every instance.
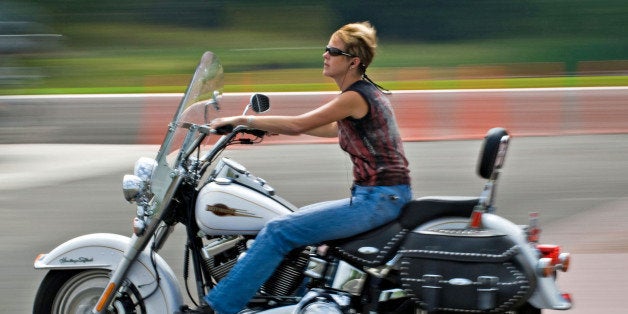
[205,185,412,314]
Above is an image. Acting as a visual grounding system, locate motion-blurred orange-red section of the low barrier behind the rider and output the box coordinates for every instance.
[137,87,628,144]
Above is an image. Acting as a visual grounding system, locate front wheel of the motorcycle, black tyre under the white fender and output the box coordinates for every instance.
[33,269,146,314]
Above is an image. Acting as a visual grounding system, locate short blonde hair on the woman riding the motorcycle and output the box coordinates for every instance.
[332,21,377,73]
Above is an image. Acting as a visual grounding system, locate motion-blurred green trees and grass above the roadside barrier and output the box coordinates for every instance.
[0,0,628,95]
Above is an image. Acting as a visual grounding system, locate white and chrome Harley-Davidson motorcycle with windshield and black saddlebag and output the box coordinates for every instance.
[33,52,572,314]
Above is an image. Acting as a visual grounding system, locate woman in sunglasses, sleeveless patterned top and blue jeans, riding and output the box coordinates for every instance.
[193,22,412,314]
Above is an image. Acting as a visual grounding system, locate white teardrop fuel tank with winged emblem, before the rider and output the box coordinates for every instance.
[195,158,296,235]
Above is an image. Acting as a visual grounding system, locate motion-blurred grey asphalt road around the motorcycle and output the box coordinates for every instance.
[0,134,628,314]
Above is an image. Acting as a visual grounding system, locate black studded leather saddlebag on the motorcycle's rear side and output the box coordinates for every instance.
[399,229,535,313]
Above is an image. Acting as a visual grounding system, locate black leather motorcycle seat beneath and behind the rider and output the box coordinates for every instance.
[327,196,479,267]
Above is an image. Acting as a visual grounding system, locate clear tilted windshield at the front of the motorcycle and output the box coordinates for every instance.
[152,51,224,206]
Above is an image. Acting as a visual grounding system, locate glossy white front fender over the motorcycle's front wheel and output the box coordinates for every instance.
[34,233,183,313]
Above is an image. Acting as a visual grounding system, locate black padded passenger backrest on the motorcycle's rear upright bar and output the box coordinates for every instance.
[478,128,510,179]
